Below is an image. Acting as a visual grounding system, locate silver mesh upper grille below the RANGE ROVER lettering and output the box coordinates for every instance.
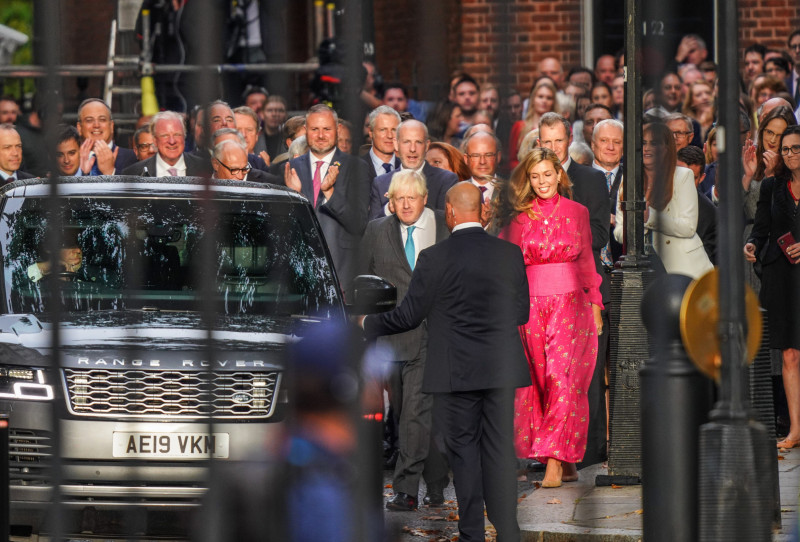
[64,369,280,419]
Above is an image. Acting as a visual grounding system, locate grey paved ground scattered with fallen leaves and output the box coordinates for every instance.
[384,448,800,542]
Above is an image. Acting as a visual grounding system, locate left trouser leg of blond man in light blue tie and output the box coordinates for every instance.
[394,349,433,497]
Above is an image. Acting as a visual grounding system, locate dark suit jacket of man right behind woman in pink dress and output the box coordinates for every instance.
[567,160,611,305]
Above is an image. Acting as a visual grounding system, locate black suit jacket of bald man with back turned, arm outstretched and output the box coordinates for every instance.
[364,227,531,393]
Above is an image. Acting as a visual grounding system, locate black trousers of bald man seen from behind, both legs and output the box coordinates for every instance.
[433,388,520,542]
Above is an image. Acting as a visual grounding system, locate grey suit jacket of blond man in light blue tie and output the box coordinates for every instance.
[357,211,450,361]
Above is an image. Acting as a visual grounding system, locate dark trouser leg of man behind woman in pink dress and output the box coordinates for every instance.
[581,309,609,467]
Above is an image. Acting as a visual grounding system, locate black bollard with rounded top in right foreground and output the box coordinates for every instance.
[639,275,713,542]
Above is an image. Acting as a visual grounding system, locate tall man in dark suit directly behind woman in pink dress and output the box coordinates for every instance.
[539,113,611,465]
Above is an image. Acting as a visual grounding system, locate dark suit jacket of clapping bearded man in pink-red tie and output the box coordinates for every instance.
[289,149,369,291]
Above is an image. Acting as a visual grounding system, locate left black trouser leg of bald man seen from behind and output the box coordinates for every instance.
[433,392,486,542]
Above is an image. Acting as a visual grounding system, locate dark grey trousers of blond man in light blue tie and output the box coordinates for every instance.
[388,347,448,497]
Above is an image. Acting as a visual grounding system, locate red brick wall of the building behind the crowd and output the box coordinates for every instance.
[375,0,800,99]
